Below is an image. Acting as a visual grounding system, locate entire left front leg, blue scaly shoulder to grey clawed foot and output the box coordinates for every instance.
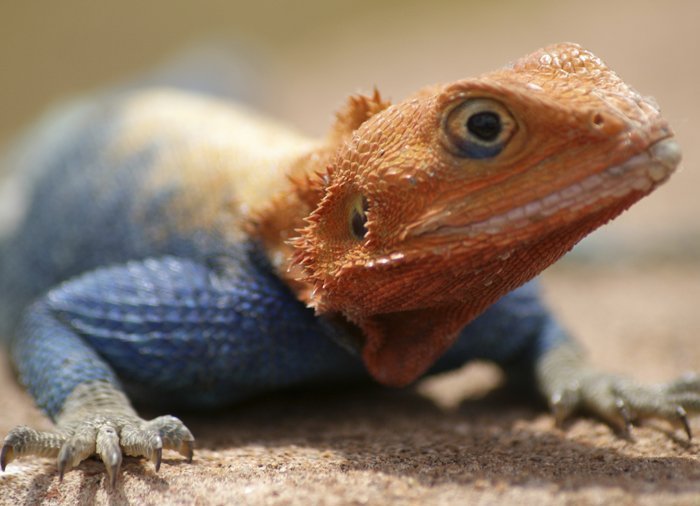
[2,251,366,481]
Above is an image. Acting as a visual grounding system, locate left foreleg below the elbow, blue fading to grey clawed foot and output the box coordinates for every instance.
[0,297,194,484]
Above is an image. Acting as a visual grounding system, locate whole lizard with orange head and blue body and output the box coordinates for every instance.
[0,43,700,484]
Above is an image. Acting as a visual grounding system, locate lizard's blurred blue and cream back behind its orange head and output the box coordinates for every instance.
[0,89,310,334]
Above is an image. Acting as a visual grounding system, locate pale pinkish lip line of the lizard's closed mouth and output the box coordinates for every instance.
[402,137,681,239]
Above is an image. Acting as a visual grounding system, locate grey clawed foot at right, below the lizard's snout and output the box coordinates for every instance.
[541,347,700,440]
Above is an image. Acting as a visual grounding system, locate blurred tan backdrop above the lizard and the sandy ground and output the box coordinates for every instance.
[0,0,700,259]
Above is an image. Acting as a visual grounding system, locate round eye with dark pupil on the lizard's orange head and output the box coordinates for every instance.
[442,98,517,159]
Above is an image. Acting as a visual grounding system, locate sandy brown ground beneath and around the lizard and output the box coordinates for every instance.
[0,265,700,505]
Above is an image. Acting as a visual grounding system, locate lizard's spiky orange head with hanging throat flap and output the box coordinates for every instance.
[293,44,680,385]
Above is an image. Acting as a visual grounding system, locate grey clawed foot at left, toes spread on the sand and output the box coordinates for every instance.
[0,414,194,486]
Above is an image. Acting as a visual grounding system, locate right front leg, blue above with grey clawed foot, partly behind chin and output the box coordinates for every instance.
[437,282,700,437]
